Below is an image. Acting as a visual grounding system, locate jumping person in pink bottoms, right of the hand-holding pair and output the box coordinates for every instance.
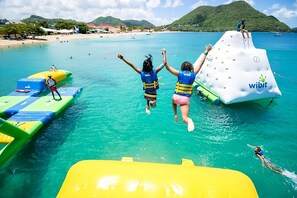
[162,45,212,132]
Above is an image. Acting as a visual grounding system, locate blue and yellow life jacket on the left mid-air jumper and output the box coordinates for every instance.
[140,70,159,91]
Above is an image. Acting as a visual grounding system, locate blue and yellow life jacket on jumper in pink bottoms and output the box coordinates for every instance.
[174,71,196,97]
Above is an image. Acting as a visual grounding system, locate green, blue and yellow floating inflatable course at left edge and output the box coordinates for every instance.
[0,70,82,166]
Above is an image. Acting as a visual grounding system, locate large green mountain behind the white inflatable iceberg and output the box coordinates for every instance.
[168,1,292,32]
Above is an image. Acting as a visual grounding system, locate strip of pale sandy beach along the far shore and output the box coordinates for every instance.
[0,32,147,49]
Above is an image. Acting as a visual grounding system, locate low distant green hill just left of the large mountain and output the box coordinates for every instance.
[91,16,155,28]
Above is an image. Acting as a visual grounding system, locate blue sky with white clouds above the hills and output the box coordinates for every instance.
[0,0,297,28]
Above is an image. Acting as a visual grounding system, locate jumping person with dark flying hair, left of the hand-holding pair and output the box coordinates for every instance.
[118,54,164,114]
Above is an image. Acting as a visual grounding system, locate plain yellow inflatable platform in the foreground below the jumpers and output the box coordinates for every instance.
[57,158,258,198]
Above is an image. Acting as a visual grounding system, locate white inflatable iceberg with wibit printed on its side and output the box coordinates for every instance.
[194,31,281,104]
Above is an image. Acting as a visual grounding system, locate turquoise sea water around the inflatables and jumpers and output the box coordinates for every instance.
[0,33,297,198]
